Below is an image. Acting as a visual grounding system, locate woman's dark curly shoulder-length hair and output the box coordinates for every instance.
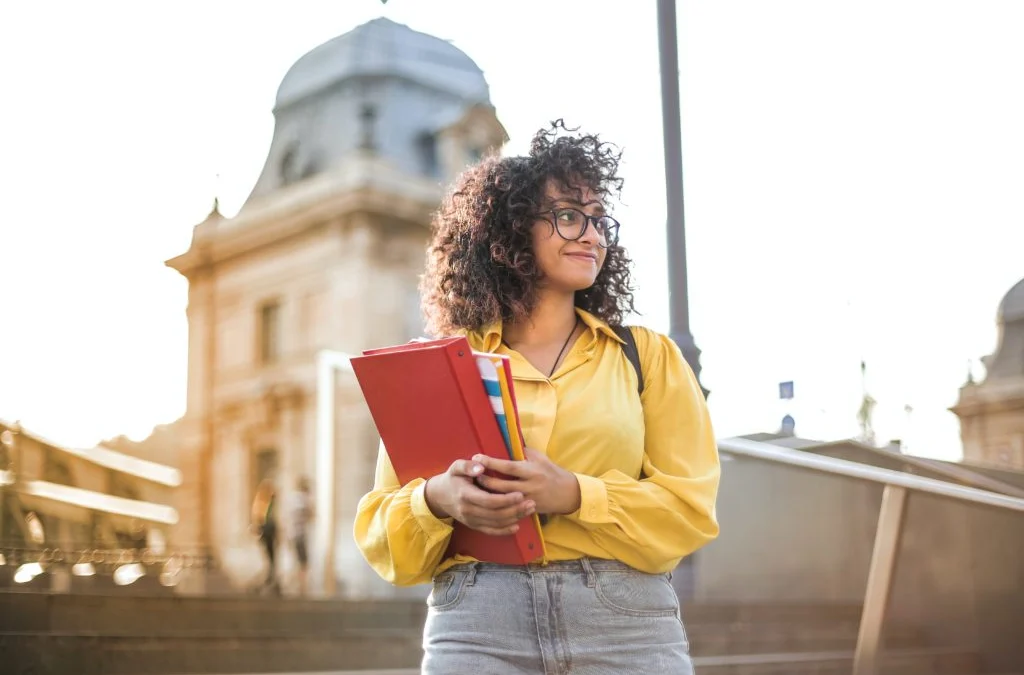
[420,120,635,336]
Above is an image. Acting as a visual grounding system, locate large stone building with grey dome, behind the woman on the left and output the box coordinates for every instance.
[167,18,507,595]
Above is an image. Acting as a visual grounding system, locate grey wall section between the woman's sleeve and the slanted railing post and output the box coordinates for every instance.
[695,458,882,602]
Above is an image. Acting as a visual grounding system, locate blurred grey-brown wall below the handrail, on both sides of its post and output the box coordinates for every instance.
[695,458,1024,668]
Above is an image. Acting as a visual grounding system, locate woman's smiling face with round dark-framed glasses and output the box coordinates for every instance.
[532,181,607,293]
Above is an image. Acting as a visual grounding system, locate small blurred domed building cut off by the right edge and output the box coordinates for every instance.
[952,279,1024,470]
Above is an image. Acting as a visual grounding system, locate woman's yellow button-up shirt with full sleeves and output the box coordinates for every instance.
[354,309,720,586]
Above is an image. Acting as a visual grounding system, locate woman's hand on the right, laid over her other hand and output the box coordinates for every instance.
[473,448,581,514]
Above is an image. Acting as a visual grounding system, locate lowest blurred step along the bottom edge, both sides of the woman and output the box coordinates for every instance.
[0,630,979,675]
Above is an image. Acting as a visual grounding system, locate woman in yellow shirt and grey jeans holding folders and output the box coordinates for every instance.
[355,123,719,675]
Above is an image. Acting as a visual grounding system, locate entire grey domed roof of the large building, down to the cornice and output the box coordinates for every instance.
[235,18,505,210]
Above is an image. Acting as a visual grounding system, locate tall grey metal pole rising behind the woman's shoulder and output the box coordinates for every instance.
[657,0,710,396]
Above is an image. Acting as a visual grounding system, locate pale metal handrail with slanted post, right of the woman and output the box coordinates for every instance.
[718,438,1024,675]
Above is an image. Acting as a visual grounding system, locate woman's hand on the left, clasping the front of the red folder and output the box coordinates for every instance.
[424,460,536,535]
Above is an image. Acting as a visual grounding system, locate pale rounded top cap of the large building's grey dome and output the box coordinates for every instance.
[276,18,489,109]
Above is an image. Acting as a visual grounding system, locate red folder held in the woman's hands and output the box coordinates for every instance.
[351,337,544,564]
